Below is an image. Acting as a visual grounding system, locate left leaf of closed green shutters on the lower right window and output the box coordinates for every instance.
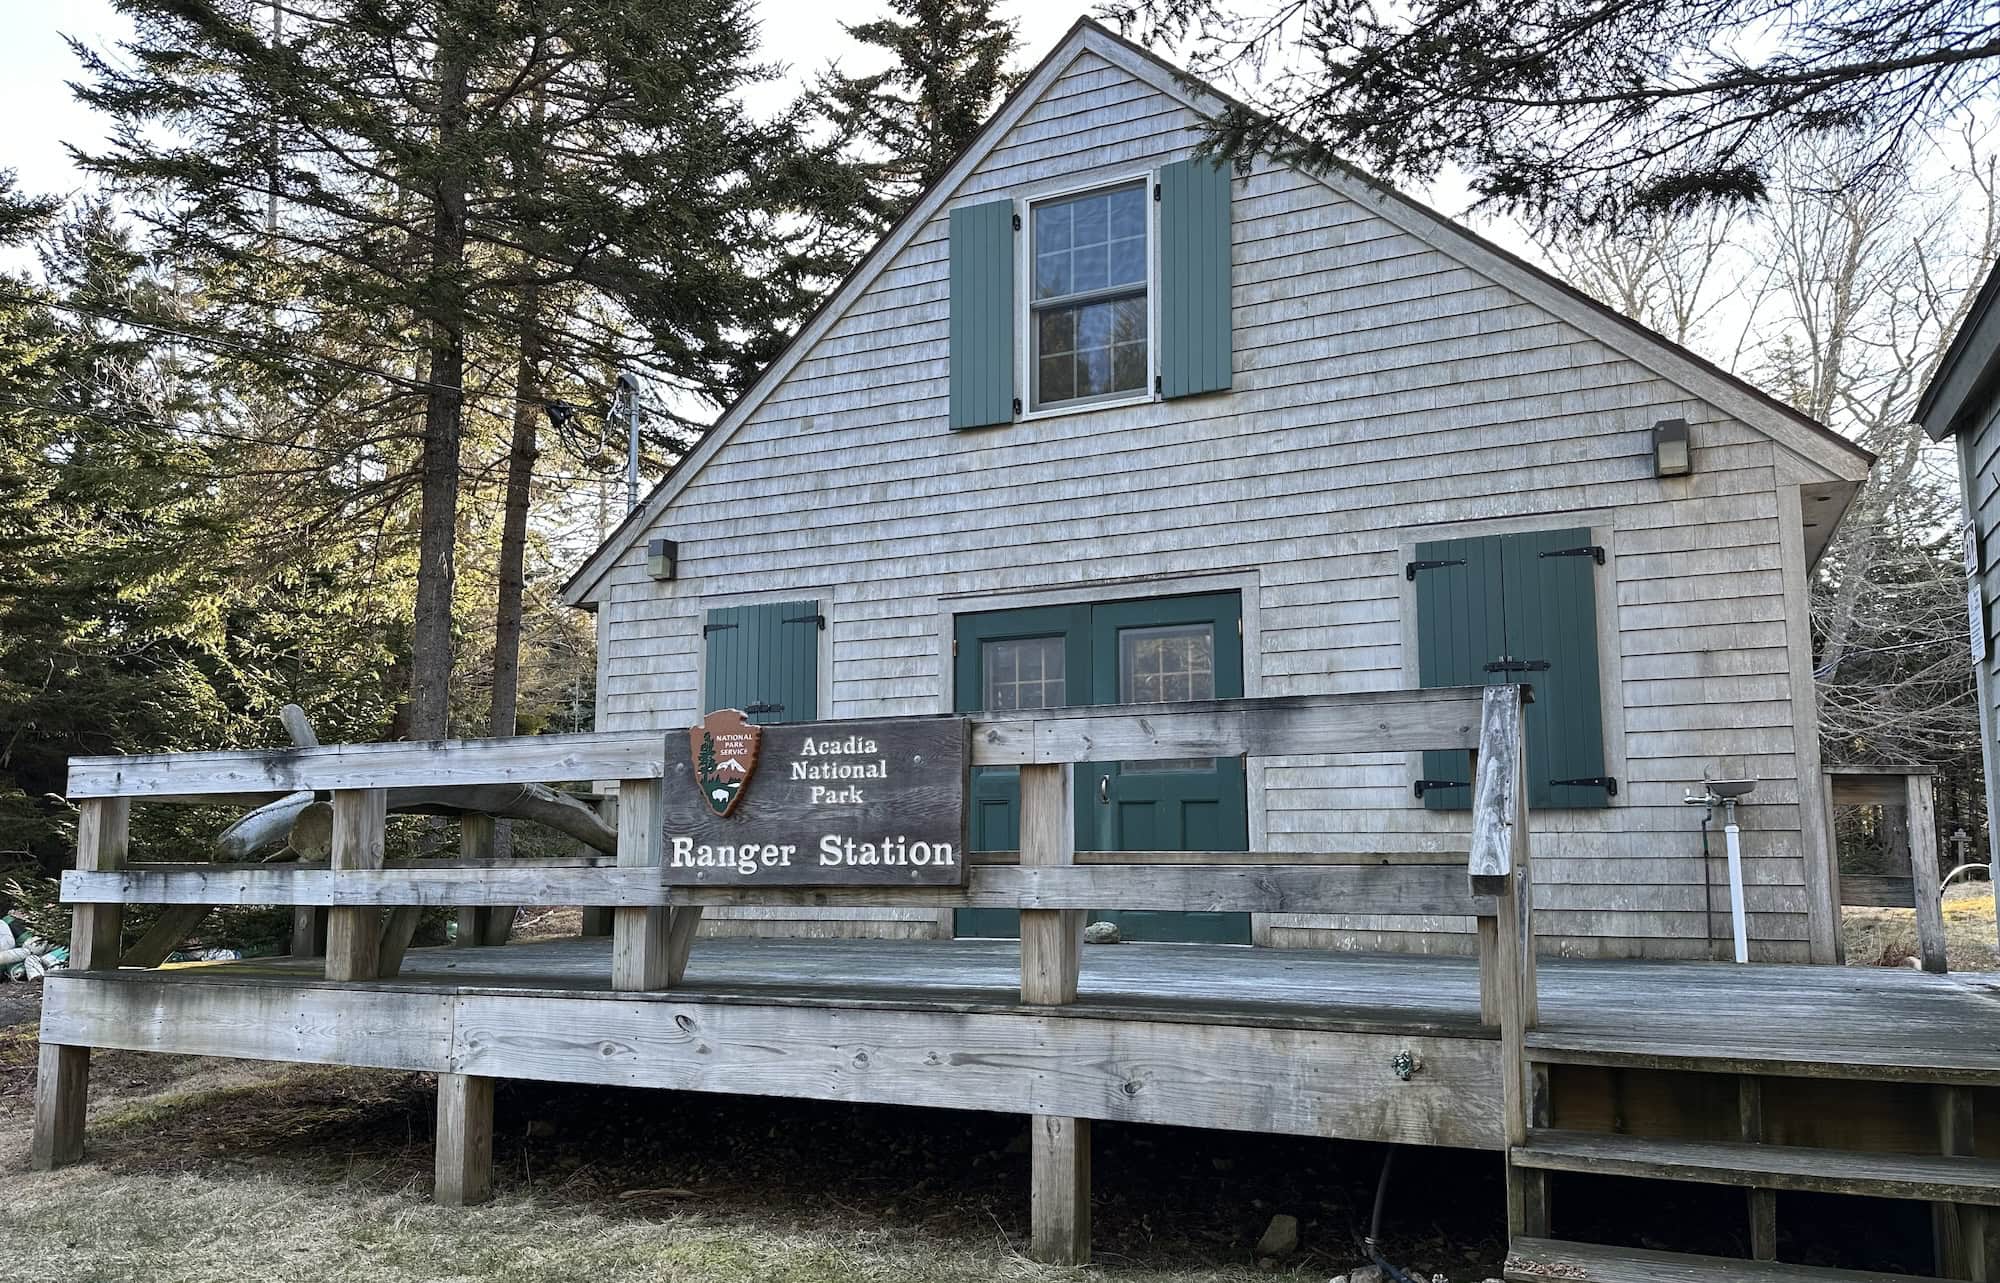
[1412,538,1506,811]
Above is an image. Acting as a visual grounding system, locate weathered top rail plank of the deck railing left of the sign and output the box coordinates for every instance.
[68,731,666,801]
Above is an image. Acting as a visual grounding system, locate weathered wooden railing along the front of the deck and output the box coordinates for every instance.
[50,685,1546,1261]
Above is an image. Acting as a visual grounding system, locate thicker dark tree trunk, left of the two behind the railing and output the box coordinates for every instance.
[410,20,466,739]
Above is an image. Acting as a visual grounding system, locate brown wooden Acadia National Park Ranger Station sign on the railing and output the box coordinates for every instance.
[662,709,972,887]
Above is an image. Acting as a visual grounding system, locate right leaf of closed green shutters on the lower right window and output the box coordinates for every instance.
[1502,530,1610,807]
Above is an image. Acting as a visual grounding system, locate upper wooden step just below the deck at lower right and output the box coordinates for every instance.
[1514,1131,2000,1207]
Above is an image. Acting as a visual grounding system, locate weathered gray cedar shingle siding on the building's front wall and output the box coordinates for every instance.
[590,37,1864,959]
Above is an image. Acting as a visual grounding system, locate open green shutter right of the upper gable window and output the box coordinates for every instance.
[1158,156,1230,398]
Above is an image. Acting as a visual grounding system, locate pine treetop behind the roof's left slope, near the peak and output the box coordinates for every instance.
[818,0,1020,232]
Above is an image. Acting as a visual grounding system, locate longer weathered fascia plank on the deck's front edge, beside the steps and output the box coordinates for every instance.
[450,993,1502,1149]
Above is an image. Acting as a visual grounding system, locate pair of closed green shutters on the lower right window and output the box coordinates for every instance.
[1414,530,1610,811]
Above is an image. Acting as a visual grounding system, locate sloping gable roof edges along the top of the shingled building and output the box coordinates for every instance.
[562,18,1874,606]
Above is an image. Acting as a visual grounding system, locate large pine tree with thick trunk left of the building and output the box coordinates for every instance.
[78,0,838,737]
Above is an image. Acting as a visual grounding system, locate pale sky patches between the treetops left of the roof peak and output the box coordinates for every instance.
[0,0,1090,204]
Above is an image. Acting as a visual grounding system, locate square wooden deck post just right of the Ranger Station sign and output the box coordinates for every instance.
[1020,763,1090,1265]
